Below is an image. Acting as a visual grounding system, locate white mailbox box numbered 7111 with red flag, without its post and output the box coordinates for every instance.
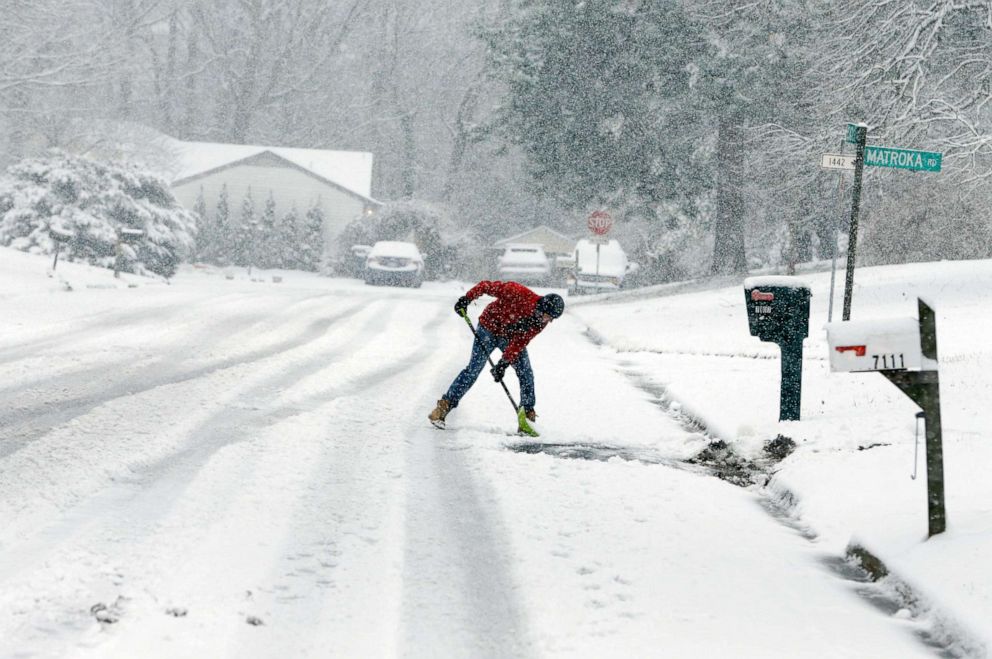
[827,318,937,372]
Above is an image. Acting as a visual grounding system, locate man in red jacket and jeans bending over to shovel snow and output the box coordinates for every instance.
[427,281,565,434]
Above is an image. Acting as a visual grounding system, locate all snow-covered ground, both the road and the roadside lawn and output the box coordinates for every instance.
[0,248,992,657]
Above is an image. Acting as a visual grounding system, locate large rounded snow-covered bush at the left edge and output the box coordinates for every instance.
[0,152,197,277]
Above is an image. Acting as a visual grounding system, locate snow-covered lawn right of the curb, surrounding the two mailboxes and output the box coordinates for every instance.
[571,261,992,654]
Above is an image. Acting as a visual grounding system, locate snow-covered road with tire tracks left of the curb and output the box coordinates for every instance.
[0,266,933,657]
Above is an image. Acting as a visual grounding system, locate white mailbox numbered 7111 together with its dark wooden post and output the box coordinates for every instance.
[827,299,947,537]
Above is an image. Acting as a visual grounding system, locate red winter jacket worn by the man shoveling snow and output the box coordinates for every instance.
[465,281,544,364]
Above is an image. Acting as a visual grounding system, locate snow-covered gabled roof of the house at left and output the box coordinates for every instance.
[169,140,372,197]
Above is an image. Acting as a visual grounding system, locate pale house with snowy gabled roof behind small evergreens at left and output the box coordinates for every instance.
[169,140,380,260]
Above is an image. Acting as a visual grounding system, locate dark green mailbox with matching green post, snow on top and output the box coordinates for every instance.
[744,277,810,421]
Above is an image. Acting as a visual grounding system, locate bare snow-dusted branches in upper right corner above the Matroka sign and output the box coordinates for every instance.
[824,0,992,180]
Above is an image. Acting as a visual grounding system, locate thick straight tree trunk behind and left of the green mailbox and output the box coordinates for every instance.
[711,110,747,274]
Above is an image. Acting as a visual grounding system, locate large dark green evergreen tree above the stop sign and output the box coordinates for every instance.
[487,0,705,212]
